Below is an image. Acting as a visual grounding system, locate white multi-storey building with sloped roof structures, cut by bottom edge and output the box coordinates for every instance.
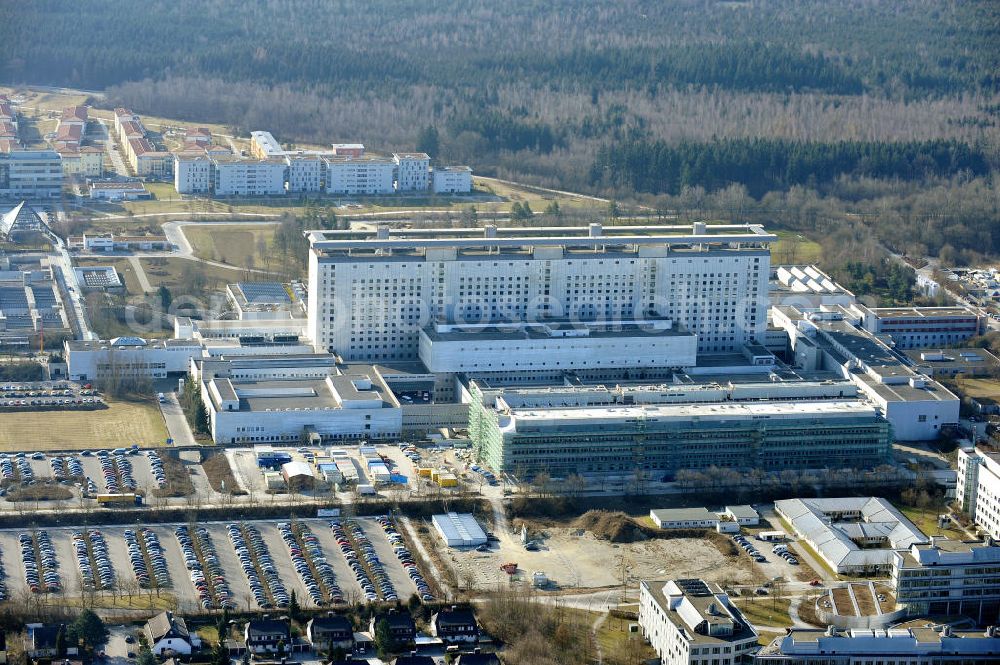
[639,579,757,665]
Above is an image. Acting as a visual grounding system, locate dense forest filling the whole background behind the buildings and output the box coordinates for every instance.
[0,0,1000,262]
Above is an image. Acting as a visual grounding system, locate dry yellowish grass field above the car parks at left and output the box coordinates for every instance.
[0,398,167,451]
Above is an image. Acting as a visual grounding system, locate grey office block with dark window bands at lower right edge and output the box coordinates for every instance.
[891,538,1000,626]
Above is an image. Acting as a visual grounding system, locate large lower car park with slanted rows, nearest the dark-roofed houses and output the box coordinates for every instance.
[0,518,432,611]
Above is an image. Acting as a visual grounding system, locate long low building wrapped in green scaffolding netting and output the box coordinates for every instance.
[469,381,892,480]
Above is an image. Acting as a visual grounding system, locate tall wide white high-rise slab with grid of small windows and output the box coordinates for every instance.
[308,224,774,361]
